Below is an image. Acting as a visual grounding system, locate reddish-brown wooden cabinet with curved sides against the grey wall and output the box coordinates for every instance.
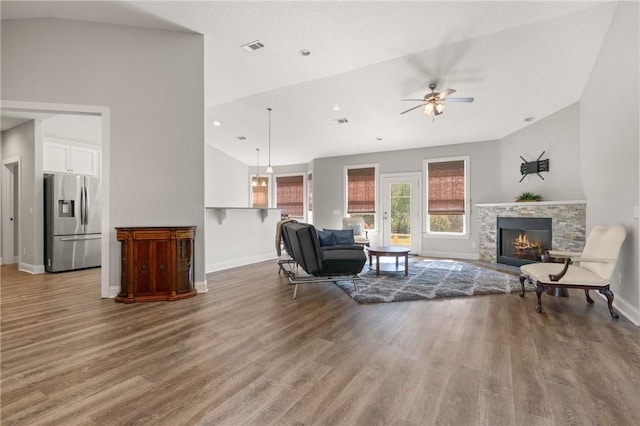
[115,226,197,303]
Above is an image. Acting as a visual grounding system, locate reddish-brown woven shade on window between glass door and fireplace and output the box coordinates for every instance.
[429,160,464,215]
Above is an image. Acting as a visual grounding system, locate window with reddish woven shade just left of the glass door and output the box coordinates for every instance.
[347,167,376,229]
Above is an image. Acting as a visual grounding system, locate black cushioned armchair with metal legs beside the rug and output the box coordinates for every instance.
[282,222,367,299]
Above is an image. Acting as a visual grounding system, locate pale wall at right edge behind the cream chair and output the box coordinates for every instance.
[580,2,640,324]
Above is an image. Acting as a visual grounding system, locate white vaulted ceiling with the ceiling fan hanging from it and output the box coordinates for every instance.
[1,0,616,165]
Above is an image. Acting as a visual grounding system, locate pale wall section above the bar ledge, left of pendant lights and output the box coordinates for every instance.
[205,144,249,207]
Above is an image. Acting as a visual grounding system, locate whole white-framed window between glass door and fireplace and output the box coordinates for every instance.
[425,158,468,235]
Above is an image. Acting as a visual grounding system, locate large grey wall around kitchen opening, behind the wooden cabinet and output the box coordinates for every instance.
[1,19,205,287]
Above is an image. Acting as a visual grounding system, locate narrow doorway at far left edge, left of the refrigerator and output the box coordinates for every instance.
[0,158,20,265]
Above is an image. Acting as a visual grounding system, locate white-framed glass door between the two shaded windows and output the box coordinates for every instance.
[381,172,422,253]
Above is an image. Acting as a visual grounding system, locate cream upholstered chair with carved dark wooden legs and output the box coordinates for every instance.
[520,226,626,318]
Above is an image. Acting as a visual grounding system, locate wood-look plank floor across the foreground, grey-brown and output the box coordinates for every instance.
[0,262,640,426]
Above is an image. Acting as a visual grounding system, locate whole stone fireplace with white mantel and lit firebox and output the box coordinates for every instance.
[476,201,587,266]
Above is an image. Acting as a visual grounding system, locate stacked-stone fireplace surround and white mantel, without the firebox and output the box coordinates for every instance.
[476,200,587,262]
